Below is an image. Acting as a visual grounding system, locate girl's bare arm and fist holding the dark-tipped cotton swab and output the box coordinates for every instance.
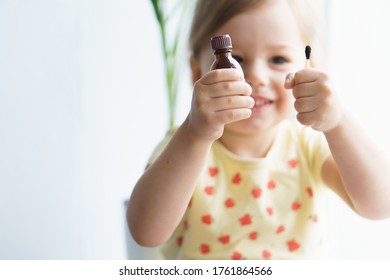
[285,69,390,219]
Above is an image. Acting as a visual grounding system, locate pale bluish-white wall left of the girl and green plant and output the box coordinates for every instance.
[0,0,178,259]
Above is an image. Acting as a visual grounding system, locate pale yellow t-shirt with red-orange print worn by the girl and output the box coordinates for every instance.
[148,121,330,259]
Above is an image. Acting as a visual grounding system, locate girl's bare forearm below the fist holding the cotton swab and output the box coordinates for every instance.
[322,116,390,219]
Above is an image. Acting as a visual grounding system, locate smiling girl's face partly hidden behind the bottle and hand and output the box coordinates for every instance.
[193,1,305,135]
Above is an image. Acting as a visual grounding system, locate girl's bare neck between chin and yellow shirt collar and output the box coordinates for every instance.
[219,127,277,158]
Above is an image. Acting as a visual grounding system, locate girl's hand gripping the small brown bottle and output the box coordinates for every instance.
[188,69,254,141]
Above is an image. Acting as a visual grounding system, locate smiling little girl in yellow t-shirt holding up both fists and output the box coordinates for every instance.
[127,0,390,259]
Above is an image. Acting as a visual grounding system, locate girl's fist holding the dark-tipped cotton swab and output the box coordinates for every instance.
[284,69,341,132]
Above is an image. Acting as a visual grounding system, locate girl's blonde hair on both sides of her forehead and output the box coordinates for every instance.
[189,0,324,66]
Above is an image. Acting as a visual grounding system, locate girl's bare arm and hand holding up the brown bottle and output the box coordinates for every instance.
[127,69,254,246]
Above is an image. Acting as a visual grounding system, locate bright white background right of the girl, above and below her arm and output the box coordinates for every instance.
[329,0,390,259]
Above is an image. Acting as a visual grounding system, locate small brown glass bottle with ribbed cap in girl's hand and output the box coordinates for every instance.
[210,34,243,73]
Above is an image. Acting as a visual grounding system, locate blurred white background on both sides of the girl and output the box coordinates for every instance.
[0,0,390,259]
